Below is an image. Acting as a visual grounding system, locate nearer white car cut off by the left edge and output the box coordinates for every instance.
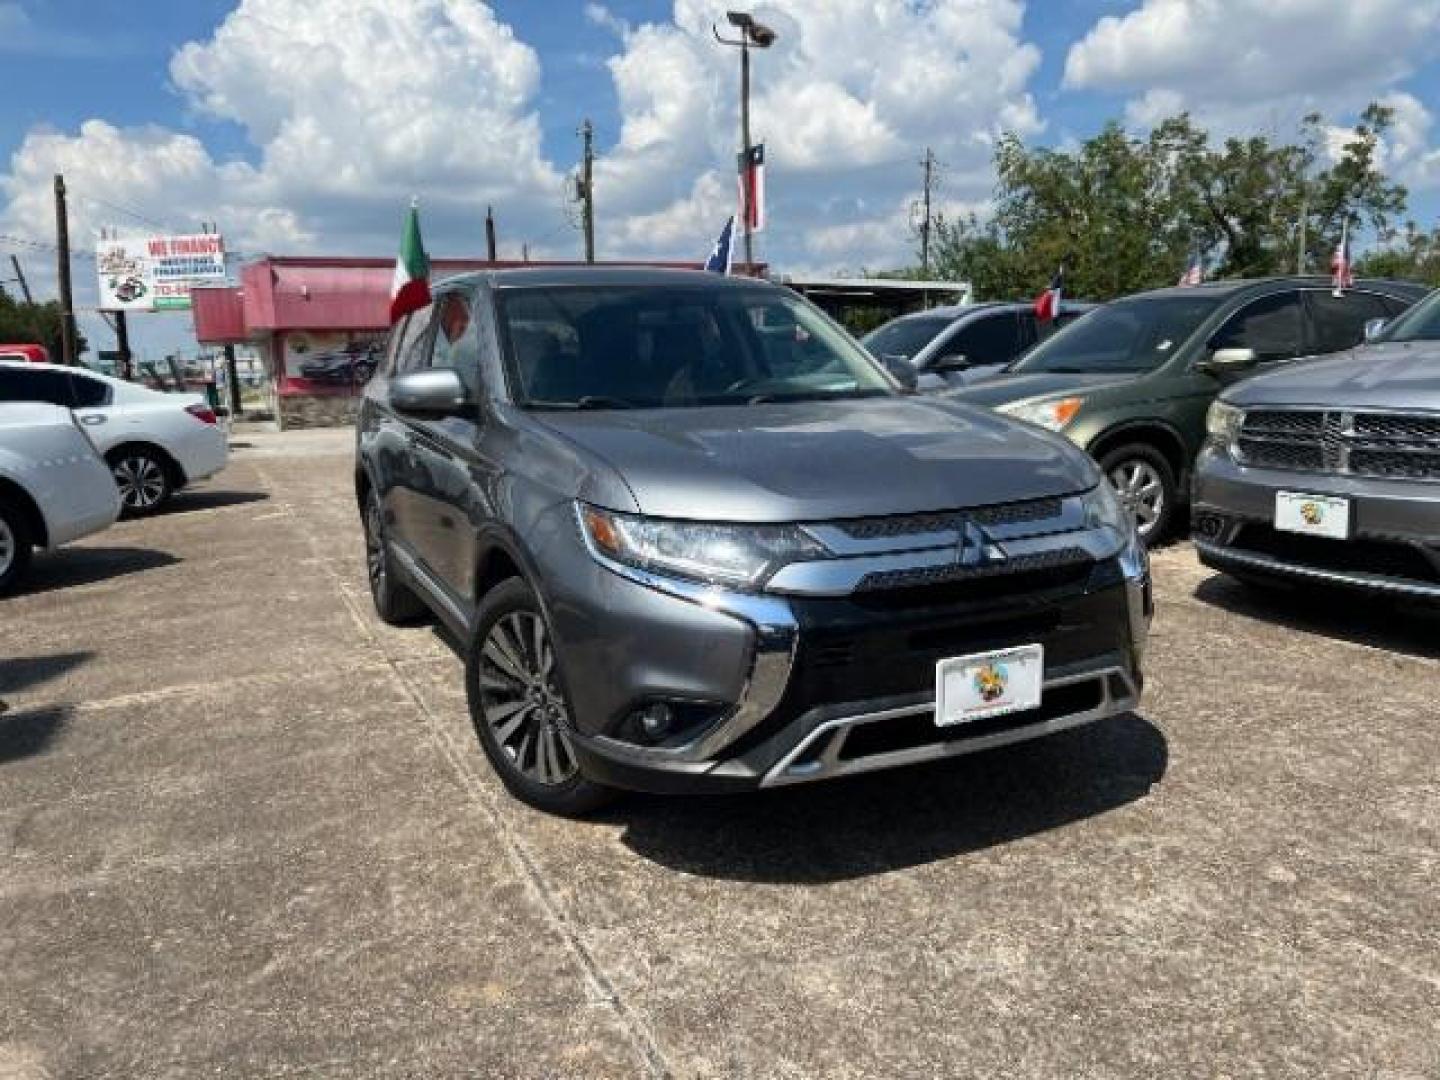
[0,402,120,596]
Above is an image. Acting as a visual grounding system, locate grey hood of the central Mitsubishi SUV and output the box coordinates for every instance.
[531,397,1097,521]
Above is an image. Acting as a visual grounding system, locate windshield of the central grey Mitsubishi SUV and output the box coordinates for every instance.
[498,285,894,409]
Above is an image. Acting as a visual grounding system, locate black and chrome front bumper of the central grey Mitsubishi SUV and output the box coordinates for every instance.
[558,529,1152,792]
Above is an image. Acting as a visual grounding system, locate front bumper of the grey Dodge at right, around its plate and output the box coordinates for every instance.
[1191,446,1440,602]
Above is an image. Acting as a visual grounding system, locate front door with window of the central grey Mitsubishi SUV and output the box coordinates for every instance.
[394,289,480,605]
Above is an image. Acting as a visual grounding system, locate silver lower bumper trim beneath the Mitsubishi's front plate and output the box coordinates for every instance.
[760,667,1140,788]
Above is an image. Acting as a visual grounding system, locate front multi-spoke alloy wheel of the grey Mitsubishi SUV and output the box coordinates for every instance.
[480,611,579,786]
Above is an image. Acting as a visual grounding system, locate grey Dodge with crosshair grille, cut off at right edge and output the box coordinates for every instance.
[1194,292,1440,602]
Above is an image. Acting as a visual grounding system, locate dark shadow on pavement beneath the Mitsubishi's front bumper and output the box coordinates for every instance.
[599,713,1169,884]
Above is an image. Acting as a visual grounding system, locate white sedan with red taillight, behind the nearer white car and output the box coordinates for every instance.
[0,363,229,517]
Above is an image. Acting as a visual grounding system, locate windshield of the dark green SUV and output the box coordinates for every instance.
[1011,295,1221,374]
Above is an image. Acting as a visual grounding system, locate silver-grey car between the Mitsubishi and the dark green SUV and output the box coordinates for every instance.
[861,300,1094,390]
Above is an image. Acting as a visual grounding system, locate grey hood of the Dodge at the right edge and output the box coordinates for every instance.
[1224,341,1440,412]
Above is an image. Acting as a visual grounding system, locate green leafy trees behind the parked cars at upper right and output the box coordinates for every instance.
[933,105,1405,300]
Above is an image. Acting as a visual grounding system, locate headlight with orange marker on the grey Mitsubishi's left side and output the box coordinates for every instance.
[577,503,829,589]
